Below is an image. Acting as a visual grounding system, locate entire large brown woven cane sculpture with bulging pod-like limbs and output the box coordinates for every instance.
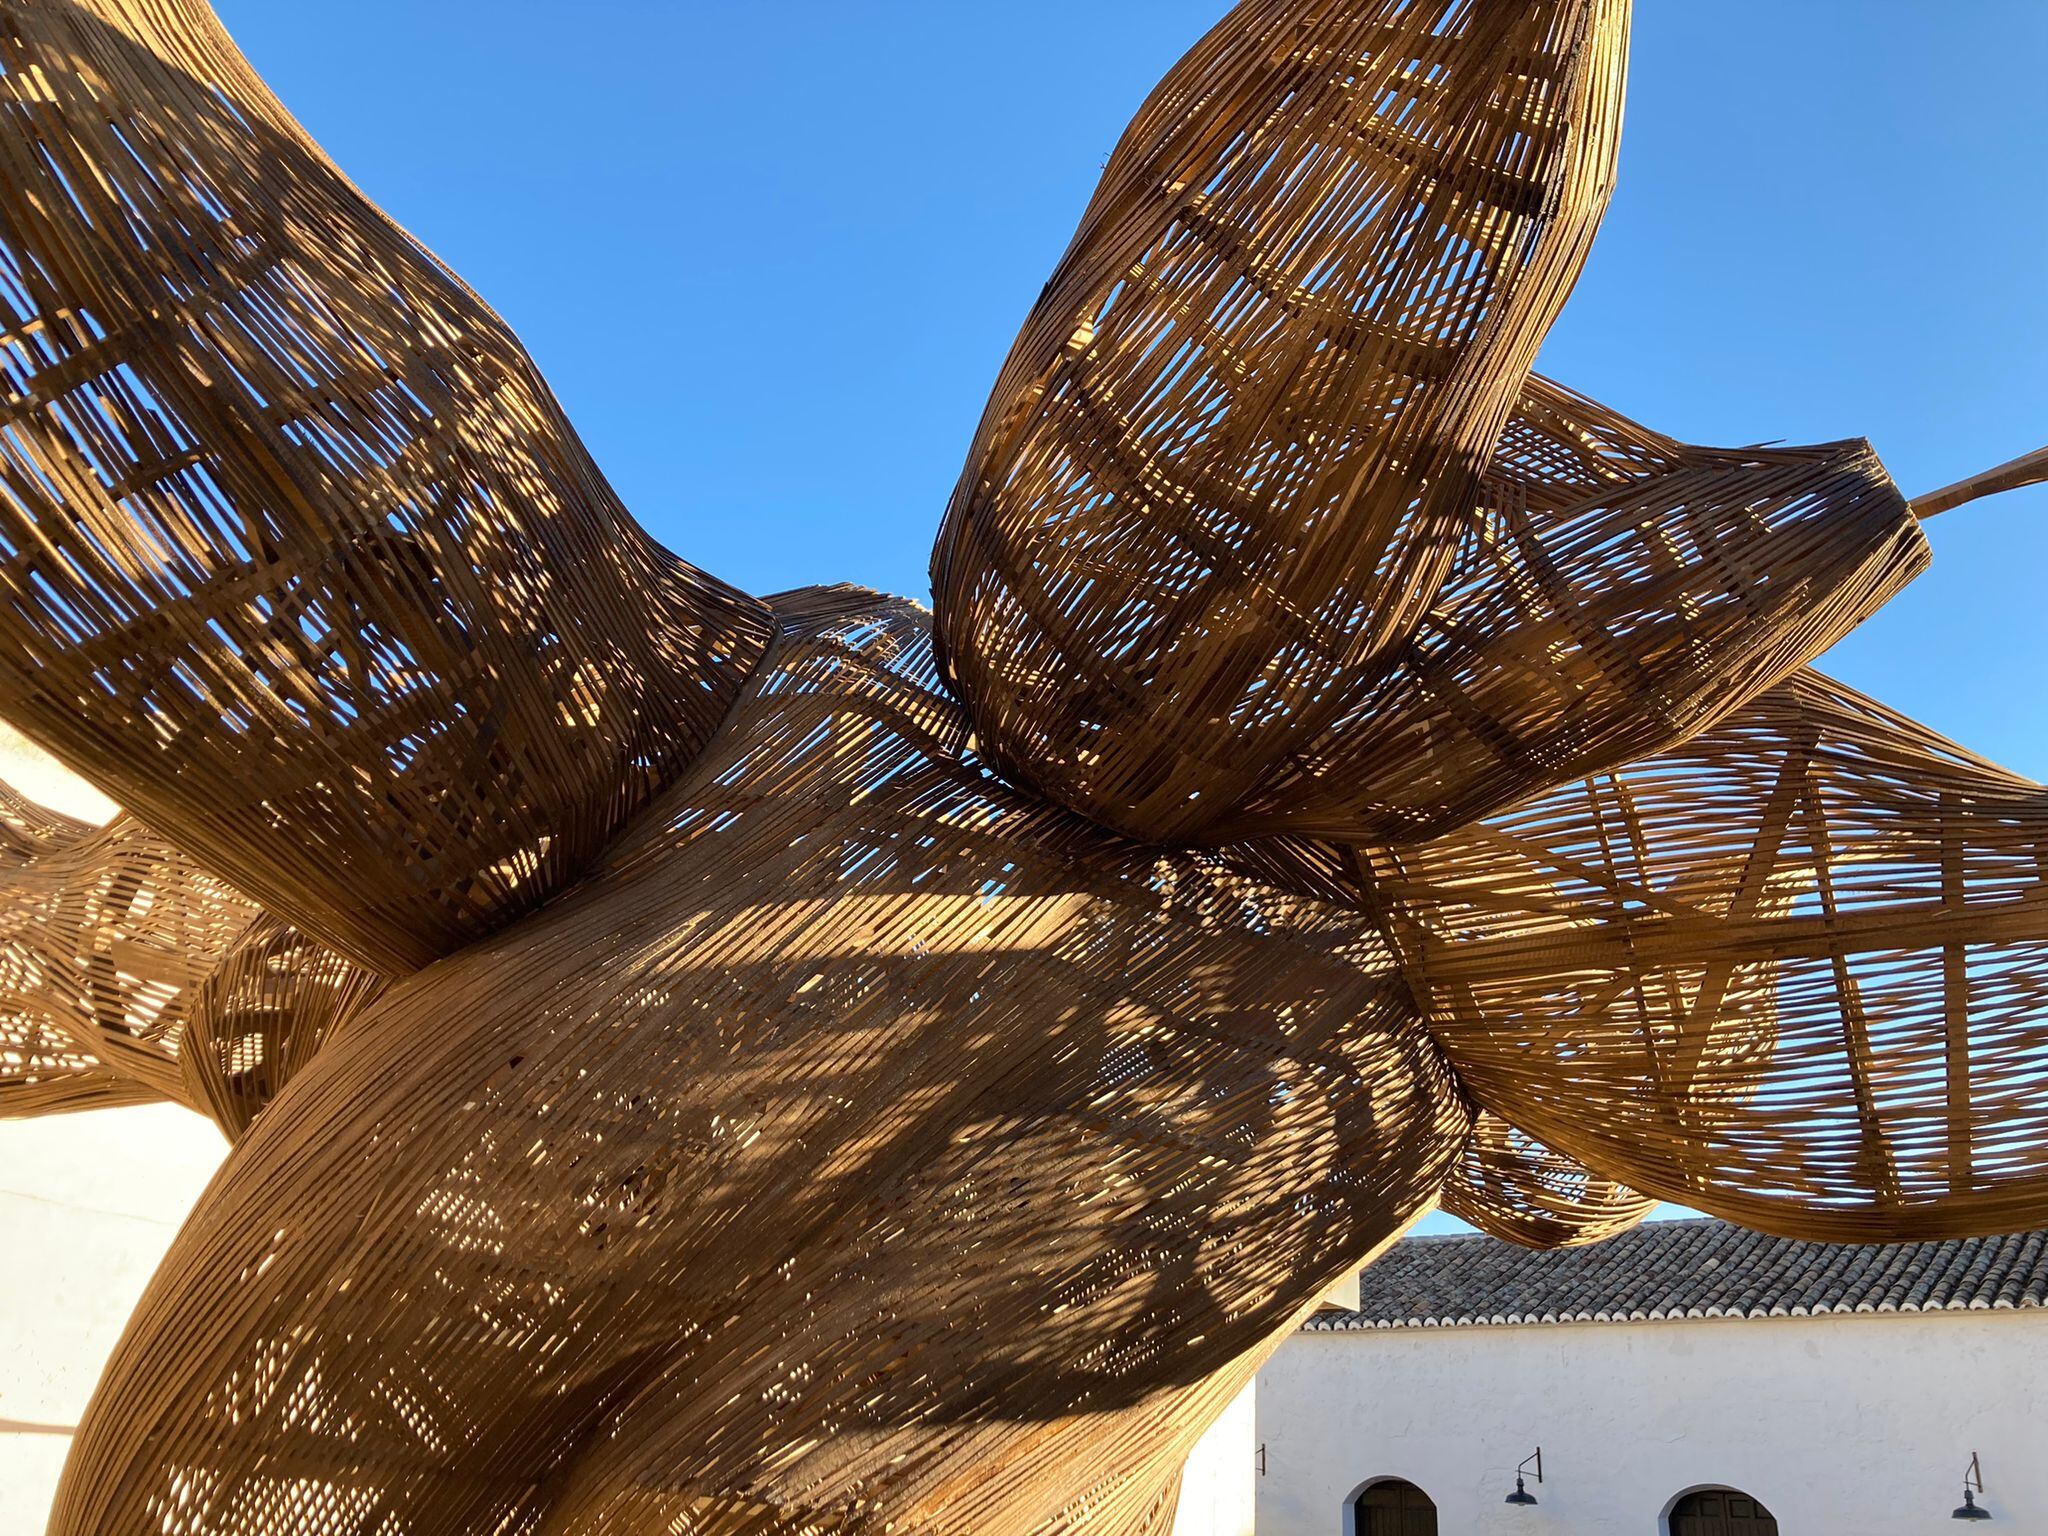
[0,0,2048,1536]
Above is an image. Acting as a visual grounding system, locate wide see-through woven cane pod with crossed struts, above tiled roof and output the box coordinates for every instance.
[1374,672,2048,1241]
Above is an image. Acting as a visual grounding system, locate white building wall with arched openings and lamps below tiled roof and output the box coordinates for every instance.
[1255,1311,2048,1536]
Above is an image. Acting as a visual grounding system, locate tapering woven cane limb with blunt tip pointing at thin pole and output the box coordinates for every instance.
[1221,379,1927,842]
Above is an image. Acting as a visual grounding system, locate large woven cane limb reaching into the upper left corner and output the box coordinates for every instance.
[0,0,766,973]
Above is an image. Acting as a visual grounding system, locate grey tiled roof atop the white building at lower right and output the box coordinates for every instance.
[1305,1219,2048,1329]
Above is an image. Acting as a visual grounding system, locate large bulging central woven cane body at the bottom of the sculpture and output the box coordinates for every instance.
[57,592,1470,1532]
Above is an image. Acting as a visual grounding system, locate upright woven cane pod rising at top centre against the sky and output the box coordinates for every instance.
[934,0,1626,840]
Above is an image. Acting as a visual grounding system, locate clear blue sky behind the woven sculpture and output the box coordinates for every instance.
[217,0,2048,1236]
